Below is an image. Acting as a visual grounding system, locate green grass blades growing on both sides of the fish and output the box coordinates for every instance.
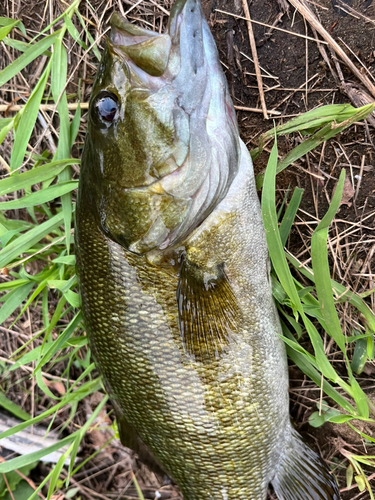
[0,0,375,500]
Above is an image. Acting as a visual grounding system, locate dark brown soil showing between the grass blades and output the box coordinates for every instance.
[0,0,375,500]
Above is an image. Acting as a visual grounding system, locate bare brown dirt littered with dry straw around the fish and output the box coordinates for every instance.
[0,0,375,500]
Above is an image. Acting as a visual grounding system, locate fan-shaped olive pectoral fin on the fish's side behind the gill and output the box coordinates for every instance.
[177,259,240,362]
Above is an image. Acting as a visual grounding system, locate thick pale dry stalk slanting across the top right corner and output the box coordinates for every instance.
[289,0,375,97]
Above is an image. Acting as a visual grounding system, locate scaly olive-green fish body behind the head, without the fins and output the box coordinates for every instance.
[78,143,290,500]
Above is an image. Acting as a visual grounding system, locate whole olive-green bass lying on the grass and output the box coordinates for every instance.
[75,0,340,500]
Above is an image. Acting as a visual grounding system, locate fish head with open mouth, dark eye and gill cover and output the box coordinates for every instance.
[80,0,240,254]
